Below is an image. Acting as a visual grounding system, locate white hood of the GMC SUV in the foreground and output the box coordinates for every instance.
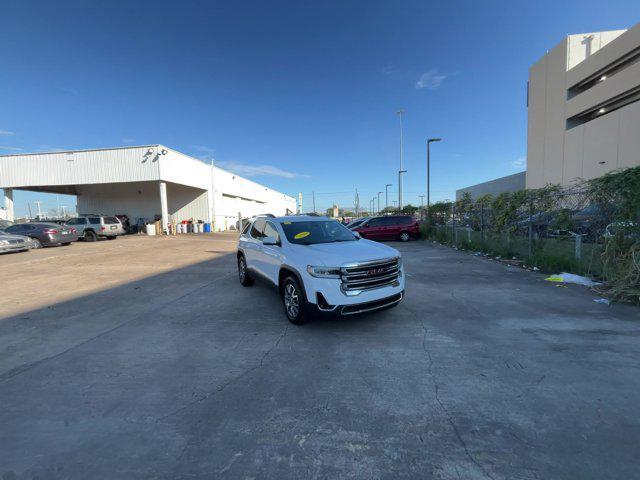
[292,238,400,267]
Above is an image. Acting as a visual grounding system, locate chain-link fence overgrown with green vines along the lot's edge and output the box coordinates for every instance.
[425,187,625,278]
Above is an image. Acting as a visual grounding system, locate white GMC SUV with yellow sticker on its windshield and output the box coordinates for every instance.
[238,216,404,325]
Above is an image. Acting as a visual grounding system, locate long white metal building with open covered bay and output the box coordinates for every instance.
[0,145,296,230]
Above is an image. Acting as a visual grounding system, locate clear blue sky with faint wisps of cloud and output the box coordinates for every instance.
[0,0,640,213]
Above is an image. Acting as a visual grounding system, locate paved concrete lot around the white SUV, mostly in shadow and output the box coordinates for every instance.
[0,235,640,480]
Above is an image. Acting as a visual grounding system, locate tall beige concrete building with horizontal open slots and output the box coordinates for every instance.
[526,24,640,188]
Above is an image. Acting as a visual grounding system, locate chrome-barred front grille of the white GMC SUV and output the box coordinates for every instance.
[340,257,400,295]
